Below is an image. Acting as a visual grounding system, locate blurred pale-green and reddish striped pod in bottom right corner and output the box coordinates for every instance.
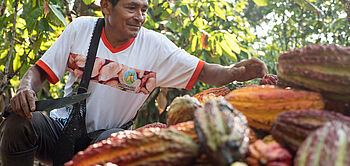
[294,121,350,166]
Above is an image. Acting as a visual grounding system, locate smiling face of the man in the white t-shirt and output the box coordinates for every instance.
[108,0,148,38]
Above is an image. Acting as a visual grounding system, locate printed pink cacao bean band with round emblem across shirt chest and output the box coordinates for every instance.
[68,53,156,94]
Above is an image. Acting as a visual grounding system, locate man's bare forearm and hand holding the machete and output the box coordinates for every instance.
[10,65,48,119]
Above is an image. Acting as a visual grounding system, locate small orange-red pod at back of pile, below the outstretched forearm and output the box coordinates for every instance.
[193,86,231,103]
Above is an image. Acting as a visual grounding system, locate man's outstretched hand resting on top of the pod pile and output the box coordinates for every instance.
[230,58,267,82]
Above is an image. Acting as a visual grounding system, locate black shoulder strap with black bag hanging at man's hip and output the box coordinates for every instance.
[53,18,104,166]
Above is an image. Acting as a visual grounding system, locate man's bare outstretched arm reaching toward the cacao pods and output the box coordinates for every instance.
[198,58,267,86]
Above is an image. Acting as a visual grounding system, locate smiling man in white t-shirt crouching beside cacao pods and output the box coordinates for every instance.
[1,0,267,165]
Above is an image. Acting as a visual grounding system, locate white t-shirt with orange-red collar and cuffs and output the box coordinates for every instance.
[36,17,204,132]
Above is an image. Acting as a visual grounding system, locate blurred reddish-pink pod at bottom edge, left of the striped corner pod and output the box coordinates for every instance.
[246,140,292,166]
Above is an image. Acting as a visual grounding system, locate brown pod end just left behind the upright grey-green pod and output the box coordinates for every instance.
[167,95,202,126]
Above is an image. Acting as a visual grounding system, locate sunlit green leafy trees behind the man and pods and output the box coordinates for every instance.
[0,0,350,127]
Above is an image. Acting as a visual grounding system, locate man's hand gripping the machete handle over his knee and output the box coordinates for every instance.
[10,88,37,119]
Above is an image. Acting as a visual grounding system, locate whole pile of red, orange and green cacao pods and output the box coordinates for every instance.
[65,45,350,166]
